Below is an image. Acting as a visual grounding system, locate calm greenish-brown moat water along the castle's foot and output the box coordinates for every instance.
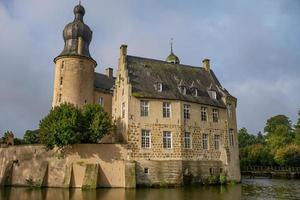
[0,179,300,200]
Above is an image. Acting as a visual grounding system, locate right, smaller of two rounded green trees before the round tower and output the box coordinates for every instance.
[81,104,112,143]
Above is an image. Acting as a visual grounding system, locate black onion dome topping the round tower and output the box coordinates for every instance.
[59,4,93,58]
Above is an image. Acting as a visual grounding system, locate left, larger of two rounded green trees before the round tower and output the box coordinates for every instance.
[39,103,83,149]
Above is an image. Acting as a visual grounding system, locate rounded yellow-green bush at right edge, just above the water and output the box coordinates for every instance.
[274,144,300,166]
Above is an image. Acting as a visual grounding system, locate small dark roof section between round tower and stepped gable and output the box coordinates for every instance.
[94,72,115,92]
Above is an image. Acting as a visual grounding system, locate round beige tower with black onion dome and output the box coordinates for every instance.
[52,4,97,107]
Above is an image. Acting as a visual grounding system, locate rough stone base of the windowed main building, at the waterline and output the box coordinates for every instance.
[136,160,224,186]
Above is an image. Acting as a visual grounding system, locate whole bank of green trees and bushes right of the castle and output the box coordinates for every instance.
[239,111,300,166]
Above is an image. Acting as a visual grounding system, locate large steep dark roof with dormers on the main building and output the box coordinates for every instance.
[126,56,230,107]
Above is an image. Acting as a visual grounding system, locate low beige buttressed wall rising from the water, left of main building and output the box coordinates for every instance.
[0,144,135,188]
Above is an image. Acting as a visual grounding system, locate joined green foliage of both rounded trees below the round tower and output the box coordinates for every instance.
[39,103,111,149]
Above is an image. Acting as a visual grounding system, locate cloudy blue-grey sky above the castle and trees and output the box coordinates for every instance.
[0,0,300,137]
